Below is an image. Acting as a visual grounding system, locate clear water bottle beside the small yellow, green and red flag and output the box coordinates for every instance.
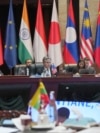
[49,91,58,122]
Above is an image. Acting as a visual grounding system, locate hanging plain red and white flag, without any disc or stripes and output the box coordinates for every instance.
[33,0,47,62]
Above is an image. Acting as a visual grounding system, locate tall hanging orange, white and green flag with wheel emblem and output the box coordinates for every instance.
[18,0,33,64]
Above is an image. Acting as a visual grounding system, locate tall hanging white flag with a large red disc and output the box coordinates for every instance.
[48,0,63,67]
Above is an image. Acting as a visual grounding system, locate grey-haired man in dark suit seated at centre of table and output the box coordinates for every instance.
[36,57,57,77]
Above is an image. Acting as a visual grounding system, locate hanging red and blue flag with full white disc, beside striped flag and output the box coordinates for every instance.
[63,0,79,64]
